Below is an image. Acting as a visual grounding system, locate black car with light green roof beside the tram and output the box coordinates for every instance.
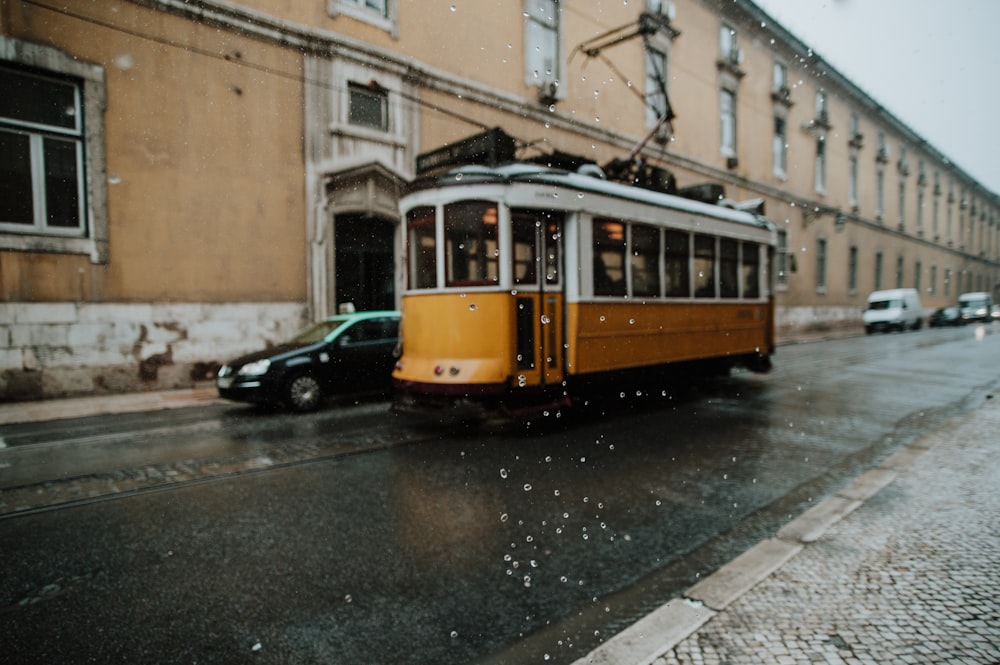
[215,311,400,411]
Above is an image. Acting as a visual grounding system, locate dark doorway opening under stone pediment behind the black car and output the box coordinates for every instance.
[334,215,396,311]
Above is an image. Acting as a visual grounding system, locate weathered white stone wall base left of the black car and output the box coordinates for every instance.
[0,302,308,402]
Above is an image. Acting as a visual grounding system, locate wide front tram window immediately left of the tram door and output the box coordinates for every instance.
[444,201,500,286]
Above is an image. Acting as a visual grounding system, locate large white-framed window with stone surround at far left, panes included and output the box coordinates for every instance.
[0,37,107,263]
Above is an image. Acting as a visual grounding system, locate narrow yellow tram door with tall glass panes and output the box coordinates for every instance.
[511,210,565,387]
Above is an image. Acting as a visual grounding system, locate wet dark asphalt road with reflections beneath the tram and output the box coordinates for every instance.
[0,328,1000,664]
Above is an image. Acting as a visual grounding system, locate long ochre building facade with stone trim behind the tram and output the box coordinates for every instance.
[0,0,1000,400]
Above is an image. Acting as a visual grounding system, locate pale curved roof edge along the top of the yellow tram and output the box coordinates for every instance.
[407,162,773,228]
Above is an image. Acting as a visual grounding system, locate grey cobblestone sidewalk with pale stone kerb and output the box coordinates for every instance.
[575,391,1000,665]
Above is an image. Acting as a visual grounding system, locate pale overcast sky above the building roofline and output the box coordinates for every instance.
[754,0,1000,194]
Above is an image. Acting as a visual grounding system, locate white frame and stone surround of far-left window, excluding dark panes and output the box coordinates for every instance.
[0,36,108,264]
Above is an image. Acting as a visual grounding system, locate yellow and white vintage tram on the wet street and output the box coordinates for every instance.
[393,129,776,418]
